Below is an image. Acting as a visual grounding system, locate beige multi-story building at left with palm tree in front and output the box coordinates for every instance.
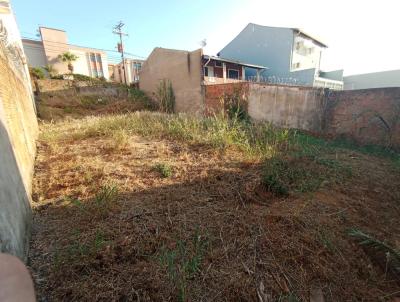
[22,27,109,79]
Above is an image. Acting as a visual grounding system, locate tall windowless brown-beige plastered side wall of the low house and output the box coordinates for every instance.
[139,48,204,114]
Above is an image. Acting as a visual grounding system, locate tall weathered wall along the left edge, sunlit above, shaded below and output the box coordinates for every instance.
[0,14,38,259]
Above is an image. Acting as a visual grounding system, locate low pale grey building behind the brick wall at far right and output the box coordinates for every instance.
[344,70,400,90]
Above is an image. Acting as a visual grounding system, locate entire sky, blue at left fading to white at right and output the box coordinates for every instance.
[11,0,400,75]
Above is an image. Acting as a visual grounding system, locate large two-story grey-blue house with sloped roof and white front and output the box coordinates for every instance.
[218,23,343,89]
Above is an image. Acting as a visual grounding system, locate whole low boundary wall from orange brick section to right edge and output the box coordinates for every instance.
[204,83,400,150]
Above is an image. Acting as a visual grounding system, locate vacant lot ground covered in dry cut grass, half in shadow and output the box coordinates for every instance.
[29,112,400,302]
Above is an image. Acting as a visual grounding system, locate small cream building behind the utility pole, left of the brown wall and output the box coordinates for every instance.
[108,59,144,85]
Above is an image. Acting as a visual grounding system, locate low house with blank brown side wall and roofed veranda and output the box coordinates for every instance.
[139,48,265,114]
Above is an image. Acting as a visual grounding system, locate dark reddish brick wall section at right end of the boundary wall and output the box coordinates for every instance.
[324,88,400,149]
